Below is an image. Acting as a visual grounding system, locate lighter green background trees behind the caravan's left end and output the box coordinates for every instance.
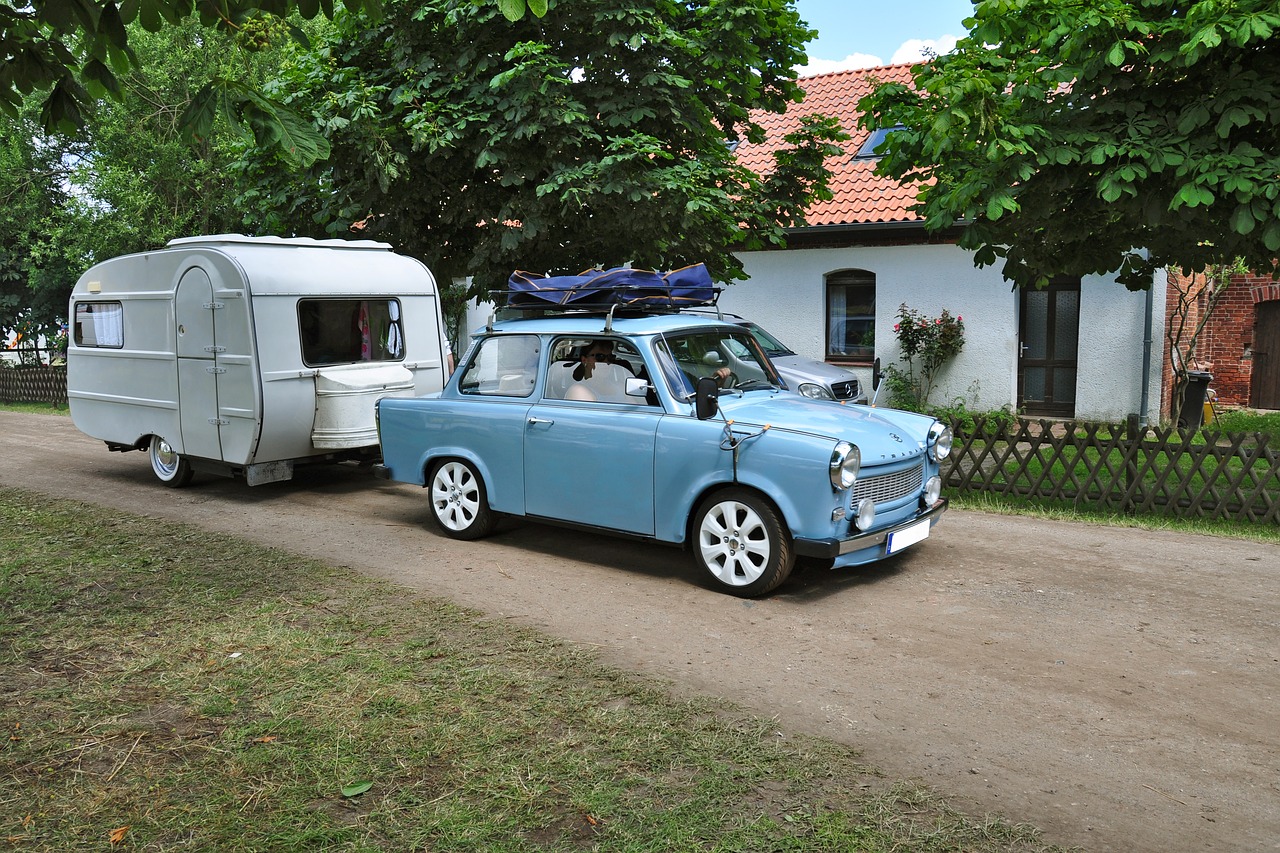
[0,20,285,333]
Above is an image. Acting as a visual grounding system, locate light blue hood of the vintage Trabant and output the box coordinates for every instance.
[719,391,934,464]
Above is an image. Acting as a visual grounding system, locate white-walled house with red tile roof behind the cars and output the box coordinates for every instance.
[721,65,1166,421]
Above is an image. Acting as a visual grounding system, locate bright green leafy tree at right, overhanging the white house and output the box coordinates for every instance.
[860,0,1280,289]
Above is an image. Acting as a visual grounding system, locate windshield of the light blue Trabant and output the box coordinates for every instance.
[655,328,781,398]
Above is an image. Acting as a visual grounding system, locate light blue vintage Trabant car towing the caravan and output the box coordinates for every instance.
[375,268,951,597]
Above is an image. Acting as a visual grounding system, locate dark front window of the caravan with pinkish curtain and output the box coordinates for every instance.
[298,298,404,366]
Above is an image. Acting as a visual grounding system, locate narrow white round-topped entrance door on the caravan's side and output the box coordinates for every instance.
[175,266,257,465]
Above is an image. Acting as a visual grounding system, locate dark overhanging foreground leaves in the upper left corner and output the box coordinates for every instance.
[0,0,379,165]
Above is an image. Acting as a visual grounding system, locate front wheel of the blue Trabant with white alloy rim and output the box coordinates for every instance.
[692,488,795,598]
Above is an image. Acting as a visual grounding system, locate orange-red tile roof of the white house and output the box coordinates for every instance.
[736,65,920,225]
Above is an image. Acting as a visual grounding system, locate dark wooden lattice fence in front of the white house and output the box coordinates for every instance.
[943,418,1280,524]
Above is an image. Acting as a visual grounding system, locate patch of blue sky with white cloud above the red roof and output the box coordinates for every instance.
[795,0,973,77]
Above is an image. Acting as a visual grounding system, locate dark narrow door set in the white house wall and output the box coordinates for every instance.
[1018,279,1080,418]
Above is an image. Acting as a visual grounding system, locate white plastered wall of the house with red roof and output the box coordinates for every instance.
[719,245,1164,421]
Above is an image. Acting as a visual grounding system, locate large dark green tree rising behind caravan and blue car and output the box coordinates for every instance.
[242,0,846,295]
